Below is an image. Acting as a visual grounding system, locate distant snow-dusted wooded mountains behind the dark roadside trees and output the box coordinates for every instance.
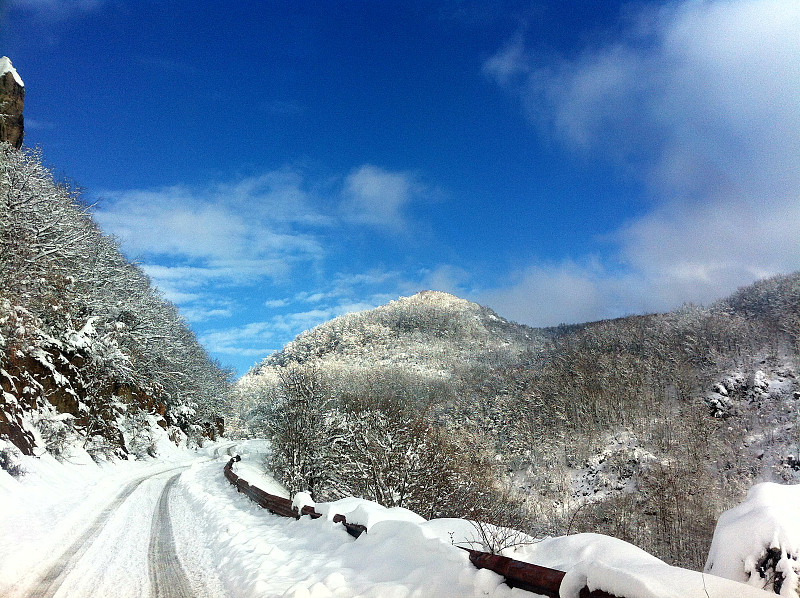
[237,274,800,568]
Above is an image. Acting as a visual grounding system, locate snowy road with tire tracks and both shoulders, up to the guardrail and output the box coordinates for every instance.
[0,441,532,598]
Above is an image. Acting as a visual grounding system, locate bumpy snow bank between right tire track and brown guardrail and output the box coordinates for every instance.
[176,463,520,598]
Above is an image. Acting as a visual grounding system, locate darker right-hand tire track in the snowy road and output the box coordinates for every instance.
[147,473,194,598]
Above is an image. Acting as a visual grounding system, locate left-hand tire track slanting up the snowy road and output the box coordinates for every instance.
[26,467,185,598]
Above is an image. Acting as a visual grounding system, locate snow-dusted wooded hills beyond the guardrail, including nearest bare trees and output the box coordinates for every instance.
[236,282,800,568]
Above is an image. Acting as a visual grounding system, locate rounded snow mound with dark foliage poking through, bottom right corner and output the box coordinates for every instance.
[705,482,800,598]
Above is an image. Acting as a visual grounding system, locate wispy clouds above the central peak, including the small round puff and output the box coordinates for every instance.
[95,165,438,370]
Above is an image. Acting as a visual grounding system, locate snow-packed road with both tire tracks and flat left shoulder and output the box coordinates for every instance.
[0,446,236,598]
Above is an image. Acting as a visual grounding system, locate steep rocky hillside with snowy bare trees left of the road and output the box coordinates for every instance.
[0,143,230,461]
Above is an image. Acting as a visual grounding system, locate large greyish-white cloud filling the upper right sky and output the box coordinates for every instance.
[484,0,800,323]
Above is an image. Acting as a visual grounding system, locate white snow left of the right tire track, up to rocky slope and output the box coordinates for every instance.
[0,442,232,597]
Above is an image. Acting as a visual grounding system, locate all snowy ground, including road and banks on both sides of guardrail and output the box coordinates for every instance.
[0,441,788,598]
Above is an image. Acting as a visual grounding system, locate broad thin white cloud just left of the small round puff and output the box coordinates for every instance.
[95,171,328,286]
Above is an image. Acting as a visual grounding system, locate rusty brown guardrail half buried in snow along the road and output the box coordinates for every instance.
[223,455,622,598]
